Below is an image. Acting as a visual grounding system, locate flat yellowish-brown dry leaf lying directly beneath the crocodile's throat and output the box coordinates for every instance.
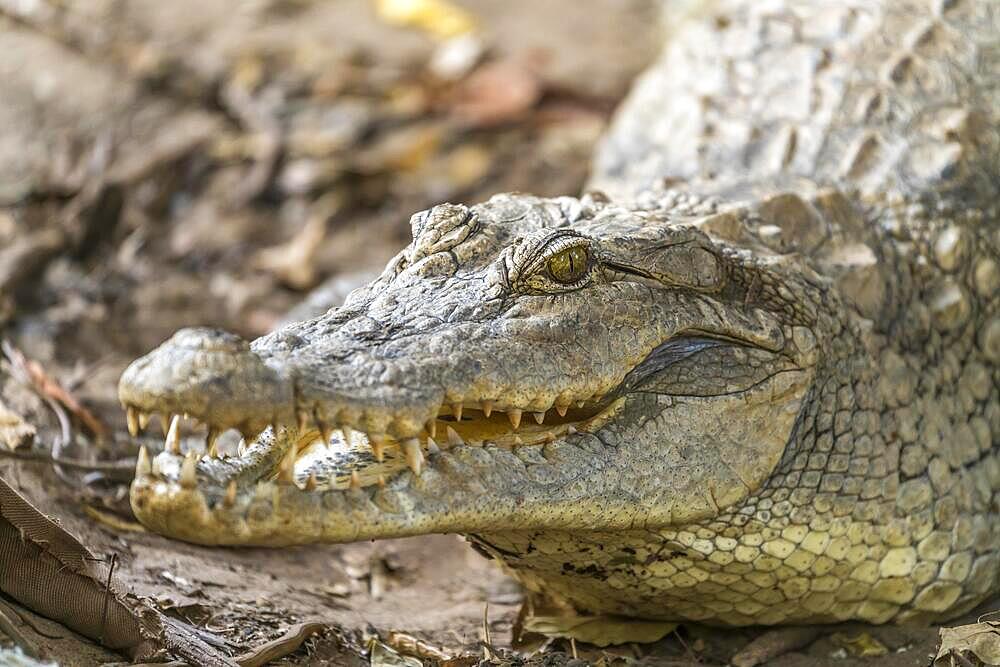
[524,616,677,646]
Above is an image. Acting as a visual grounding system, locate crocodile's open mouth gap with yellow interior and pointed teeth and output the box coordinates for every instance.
[125,396,624,494]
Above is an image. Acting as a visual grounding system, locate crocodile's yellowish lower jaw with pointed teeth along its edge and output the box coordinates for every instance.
[131,360,811,546]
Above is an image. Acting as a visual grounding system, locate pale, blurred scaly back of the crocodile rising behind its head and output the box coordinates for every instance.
[593,0,1000,206]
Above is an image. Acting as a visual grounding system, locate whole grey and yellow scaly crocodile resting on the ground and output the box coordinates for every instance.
[119,0,1000,626]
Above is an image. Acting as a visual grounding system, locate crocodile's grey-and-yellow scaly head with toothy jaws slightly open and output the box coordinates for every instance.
[119,190,829,545]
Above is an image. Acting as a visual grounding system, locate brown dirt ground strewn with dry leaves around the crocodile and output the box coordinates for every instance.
[0,0,996,666]
